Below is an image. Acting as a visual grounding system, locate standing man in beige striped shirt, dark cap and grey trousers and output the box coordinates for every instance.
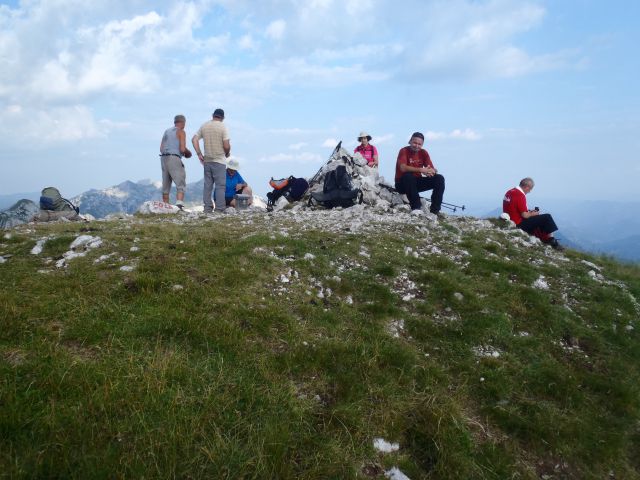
[191,108,231,213]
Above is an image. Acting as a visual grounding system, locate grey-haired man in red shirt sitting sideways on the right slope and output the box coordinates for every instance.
[502,177,564,250]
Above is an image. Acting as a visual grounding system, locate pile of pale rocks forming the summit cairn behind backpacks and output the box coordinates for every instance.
[308,142,404,209]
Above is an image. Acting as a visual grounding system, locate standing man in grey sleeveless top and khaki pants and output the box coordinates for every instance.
[160,115,191,208]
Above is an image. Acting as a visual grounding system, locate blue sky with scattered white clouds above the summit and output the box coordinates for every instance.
[0,0,640,204]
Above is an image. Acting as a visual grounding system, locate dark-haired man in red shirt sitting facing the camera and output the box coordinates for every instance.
[395,132,444,215]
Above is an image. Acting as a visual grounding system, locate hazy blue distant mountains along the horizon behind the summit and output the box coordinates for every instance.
[0,179,640,262]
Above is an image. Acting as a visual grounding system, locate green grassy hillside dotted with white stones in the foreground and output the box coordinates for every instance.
[0,207,640,480]
